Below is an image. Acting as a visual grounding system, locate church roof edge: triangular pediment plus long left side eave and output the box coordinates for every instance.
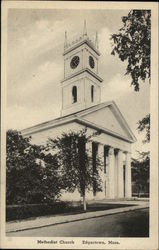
[21,101,136,143]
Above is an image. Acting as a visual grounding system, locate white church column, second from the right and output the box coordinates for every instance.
[117,150,124,198]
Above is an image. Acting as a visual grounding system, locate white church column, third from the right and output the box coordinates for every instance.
[108,147,115,199]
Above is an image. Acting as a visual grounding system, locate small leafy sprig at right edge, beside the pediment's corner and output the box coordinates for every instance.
[138,114,150,143]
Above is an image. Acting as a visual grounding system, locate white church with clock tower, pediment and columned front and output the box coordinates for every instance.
[22,23,136,200]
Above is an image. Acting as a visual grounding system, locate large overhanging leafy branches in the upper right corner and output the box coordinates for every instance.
[111,10,151,91]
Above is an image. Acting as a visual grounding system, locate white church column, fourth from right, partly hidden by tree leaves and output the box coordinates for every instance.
[97,144,105,199]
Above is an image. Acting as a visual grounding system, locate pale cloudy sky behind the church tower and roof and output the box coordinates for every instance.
[7,9,150,156]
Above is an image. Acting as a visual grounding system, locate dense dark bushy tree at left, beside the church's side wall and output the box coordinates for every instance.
[6,130,60,204]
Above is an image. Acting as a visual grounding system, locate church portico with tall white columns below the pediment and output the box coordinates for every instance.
[87,143,131,199]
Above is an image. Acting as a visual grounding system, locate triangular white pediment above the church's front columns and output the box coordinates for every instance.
[80,102,136,141]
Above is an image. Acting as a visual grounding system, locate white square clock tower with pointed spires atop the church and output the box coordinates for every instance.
[61,22,103,116]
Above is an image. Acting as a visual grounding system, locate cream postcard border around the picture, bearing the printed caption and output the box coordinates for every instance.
[0,1,158,250]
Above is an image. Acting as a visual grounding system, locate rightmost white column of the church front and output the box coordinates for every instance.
[125,152,132,198]
